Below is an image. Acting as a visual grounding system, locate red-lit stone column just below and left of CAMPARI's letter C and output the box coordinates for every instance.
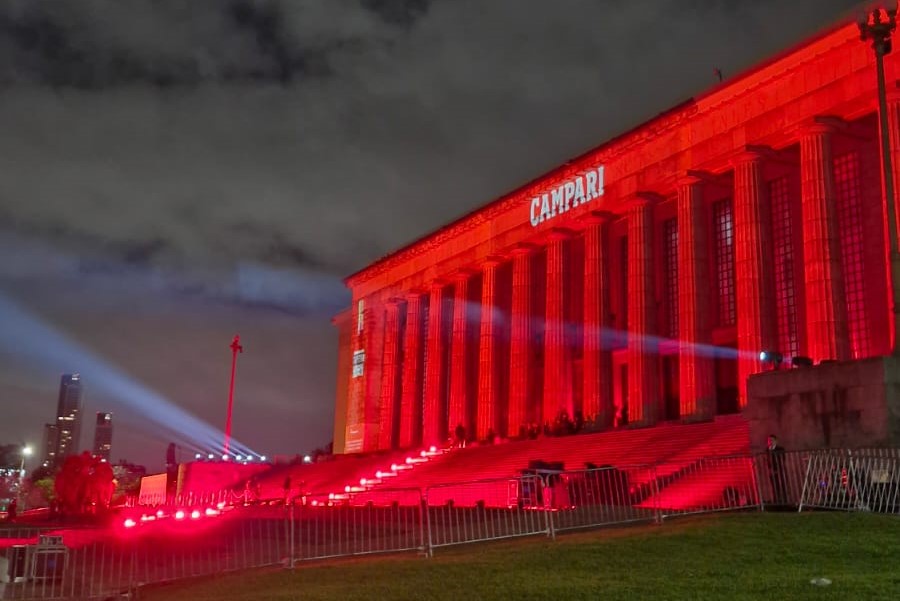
[509,245,534,436]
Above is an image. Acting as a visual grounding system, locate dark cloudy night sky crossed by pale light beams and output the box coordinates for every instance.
[0,0,856,467]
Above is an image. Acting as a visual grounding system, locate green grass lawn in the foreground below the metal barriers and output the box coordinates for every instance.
[141,513,900,601]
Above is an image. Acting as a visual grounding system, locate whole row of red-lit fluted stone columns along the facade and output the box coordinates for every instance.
[370,119,849,448]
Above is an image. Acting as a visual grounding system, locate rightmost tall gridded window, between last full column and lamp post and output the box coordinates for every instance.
[834,152,872,359]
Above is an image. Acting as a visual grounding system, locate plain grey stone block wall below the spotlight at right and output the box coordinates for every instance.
[744,357,900,452]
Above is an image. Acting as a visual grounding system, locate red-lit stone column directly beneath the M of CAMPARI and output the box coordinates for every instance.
[541,230,571,423]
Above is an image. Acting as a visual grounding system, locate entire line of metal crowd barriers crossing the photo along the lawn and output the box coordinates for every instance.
[0,449,900,600]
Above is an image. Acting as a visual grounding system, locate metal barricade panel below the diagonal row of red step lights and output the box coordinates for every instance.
[288,488,425,565]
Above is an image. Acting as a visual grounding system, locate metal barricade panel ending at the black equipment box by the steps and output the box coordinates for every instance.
[424,475,552,555]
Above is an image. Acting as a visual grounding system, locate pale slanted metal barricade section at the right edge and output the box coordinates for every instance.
[799,449,900,514]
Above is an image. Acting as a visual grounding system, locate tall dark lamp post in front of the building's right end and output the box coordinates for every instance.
[859,7,900,356]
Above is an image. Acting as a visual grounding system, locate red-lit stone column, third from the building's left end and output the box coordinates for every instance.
[422,280,447,445]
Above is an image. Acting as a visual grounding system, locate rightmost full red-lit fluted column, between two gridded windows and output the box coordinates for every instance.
[800,123,850,361]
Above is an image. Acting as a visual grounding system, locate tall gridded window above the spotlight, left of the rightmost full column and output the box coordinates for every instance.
[769,176,800,357]
